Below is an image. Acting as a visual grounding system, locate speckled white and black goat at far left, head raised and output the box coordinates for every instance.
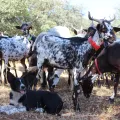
[0,23,35,83]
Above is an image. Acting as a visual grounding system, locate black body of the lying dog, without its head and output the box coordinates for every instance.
[18,90,63,114]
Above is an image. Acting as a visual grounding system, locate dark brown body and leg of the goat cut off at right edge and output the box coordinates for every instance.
[87,40,120,102]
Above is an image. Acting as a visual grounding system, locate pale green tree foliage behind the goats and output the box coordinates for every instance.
[0,0,88,35]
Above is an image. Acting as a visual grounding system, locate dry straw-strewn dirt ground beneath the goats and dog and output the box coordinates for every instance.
[0,62,120,120]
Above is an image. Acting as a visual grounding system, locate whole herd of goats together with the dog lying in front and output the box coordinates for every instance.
[0,13,120,114]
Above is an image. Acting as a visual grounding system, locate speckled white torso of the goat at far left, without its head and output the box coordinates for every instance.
[0,36,31,79]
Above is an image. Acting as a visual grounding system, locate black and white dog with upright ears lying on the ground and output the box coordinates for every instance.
[4,71,63,114]
